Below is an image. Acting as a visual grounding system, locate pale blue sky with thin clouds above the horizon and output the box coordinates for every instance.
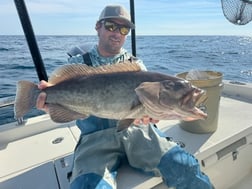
[0,0,252,36]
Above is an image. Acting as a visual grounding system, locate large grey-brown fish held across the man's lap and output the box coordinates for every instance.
[14,62,207,129]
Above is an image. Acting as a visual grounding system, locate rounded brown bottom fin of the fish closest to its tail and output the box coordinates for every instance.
[48,104,88,123]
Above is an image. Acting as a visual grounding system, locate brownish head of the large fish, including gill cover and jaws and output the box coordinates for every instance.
[135,78,207,121]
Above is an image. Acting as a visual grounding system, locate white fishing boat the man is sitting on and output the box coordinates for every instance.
[0,1,252,189]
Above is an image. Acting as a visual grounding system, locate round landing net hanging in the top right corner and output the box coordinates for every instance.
[221,0,252,25]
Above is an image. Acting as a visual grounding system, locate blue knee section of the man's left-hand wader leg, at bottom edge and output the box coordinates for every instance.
[70,173,113,189]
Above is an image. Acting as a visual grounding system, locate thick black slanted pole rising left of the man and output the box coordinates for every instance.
[14,0,48,81]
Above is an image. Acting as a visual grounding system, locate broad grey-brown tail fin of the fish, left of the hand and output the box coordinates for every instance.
[14,81,39,119]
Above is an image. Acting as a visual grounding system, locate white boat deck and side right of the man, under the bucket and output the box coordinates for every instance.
[151,97,252,189]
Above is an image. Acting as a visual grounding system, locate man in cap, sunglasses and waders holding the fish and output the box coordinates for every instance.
[37,5,212,189]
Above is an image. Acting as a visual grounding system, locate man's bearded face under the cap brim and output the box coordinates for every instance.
[97,19,127,56]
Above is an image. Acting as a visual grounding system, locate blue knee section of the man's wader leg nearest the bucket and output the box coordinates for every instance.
[158,146,212,189]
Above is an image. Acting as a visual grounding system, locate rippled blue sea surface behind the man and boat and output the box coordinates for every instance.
[0,35,252,125]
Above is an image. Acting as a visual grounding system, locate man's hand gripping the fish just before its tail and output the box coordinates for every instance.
[36,80,52,112]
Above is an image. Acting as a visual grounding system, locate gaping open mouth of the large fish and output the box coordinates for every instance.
[182,87,207,119]
